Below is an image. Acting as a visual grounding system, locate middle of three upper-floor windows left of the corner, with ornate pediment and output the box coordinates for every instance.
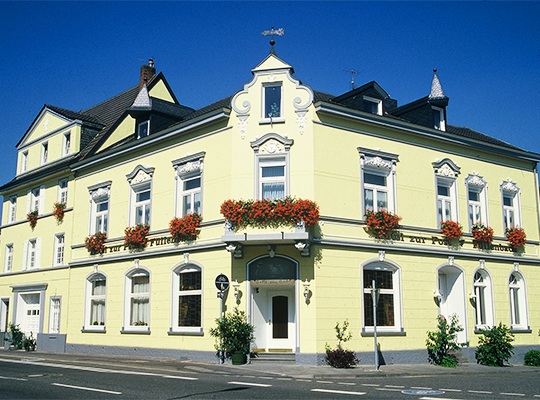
[126,165,154,226]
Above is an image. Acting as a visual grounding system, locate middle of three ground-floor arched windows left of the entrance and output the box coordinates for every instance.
[123,267,150,332]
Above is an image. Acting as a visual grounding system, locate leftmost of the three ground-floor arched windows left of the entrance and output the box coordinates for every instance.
[84,272,107,331]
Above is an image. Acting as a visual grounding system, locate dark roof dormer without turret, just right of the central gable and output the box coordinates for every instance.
[332,81,397,115]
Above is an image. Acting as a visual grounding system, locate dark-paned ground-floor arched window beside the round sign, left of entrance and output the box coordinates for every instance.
[171,265,203,333]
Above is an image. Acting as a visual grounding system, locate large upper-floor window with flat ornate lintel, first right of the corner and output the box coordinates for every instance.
[358,147,398,214]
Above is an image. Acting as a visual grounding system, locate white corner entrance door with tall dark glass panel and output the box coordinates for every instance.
[267,290,295,351]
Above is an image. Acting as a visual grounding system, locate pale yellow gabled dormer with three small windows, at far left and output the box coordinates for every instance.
[16,104,104,175]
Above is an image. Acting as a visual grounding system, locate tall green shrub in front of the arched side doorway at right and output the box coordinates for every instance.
[426,314,467,367]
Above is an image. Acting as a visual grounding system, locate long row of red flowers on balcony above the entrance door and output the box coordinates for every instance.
[221,197,319,230]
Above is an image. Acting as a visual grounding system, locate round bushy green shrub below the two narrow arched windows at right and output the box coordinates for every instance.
[476,322,514,367]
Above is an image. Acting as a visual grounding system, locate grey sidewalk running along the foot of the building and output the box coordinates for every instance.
[0,350,540,379]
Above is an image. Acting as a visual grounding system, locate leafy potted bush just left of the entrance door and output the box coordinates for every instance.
[210,307,255,365]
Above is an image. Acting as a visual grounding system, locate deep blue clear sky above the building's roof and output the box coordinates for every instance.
[0,1,540,191]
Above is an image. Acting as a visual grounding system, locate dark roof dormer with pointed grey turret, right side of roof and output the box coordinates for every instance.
[390,69,449,131]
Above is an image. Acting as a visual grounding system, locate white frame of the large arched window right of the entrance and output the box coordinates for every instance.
[361,260,403,334]
